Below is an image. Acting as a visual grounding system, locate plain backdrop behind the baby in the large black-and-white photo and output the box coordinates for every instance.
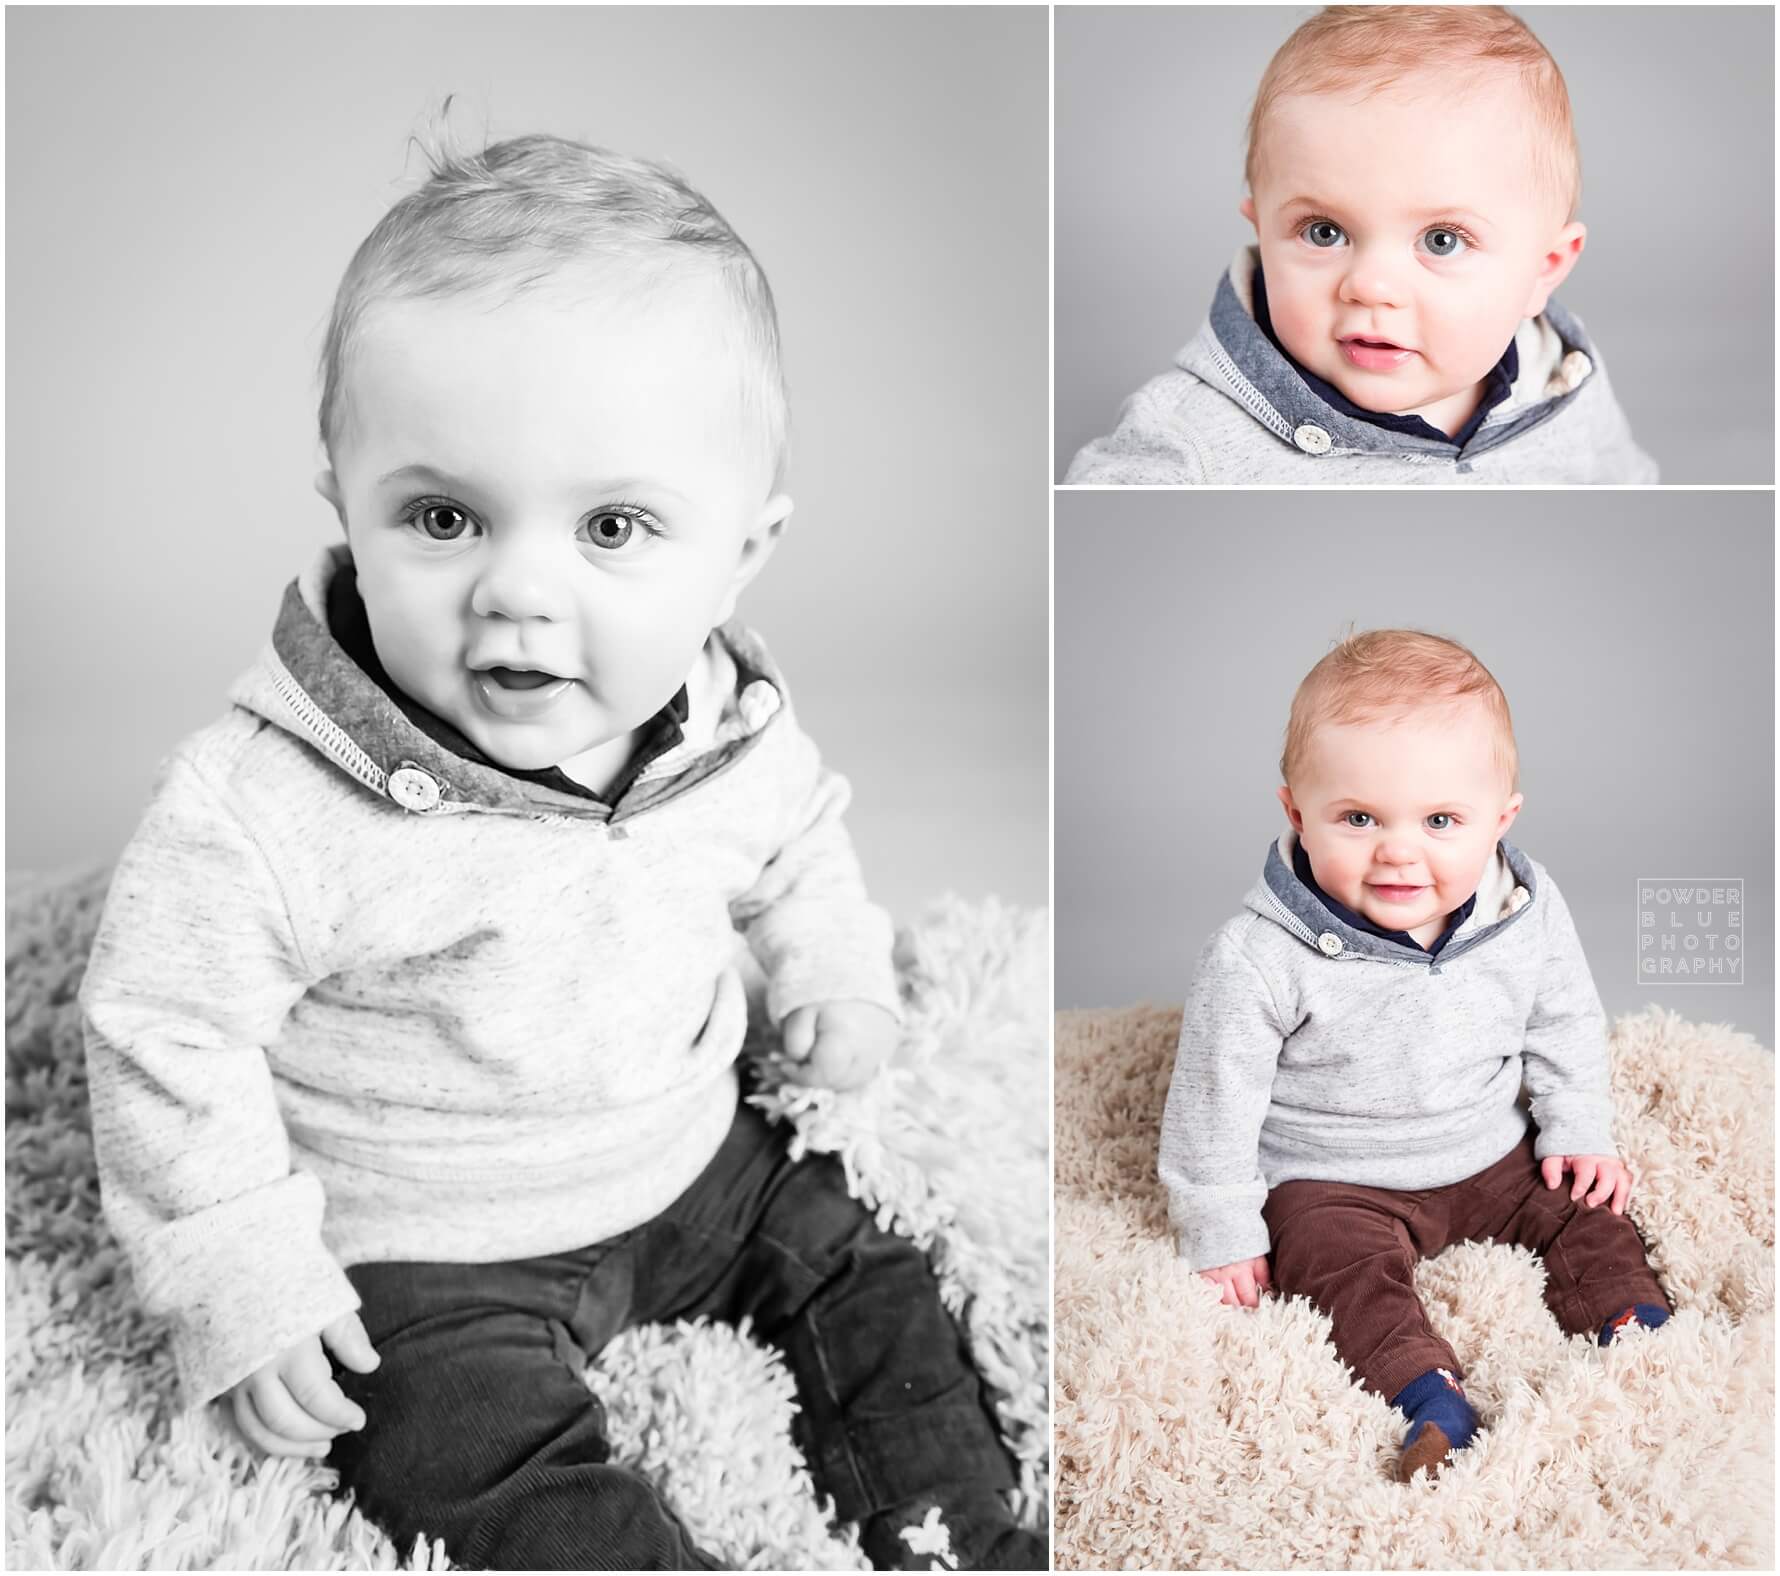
[5,5,1048,919]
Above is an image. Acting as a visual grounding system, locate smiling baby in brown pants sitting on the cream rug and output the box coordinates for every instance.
[1159,629,1670,1482]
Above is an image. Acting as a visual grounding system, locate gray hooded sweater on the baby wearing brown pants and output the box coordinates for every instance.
[1159,832,1616,1270]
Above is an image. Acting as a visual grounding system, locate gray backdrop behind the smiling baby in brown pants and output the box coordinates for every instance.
[1056,490,1775,1047]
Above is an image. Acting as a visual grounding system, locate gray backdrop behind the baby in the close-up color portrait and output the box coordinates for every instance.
[1056,5,1775,484]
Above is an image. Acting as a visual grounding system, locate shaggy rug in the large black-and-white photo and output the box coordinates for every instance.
[5,871,1050,1571]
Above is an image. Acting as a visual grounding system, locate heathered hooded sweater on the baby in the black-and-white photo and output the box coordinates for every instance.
[80,548,897,1403]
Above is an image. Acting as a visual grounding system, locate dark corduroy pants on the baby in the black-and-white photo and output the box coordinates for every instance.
[328,1106,1047,1571]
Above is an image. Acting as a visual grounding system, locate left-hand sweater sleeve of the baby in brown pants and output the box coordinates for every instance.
[1157,930,1285,1270]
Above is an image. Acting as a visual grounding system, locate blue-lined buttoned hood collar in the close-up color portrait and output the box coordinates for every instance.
[1175,246,1595,456]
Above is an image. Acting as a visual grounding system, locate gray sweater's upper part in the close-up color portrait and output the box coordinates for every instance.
[1064,246,1657,486]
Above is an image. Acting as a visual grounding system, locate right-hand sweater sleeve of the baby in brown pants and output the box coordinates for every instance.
[1522,874,1616,1159]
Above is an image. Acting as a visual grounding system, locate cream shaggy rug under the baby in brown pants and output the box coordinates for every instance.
[1054,1006,1775,1571]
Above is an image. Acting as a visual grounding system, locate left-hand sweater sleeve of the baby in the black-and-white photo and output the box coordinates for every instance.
[80,757,358,1405]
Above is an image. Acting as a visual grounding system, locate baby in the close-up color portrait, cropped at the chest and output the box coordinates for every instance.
[1066,5,1657,486]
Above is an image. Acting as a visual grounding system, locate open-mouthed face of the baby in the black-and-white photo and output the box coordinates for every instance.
[317,283,790,776]
